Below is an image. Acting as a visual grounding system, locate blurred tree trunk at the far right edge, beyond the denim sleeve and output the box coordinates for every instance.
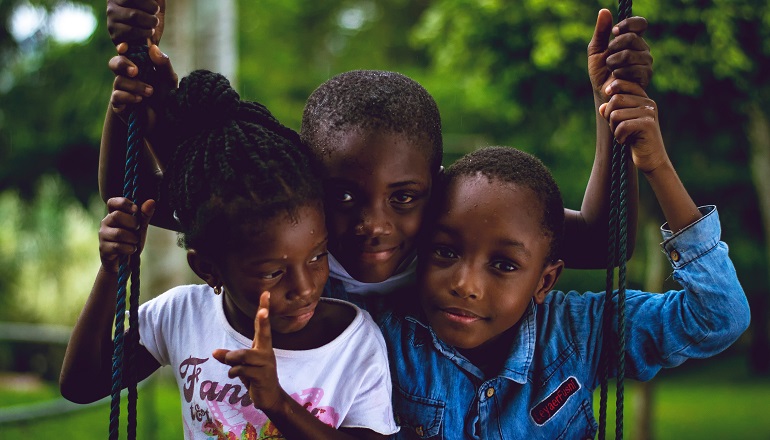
[746,102,770,375]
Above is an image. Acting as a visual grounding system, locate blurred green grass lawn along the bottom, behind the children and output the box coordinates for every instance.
[0,356,770,440]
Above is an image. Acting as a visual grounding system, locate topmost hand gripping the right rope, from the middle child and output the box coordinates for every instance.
[588,9,652,102]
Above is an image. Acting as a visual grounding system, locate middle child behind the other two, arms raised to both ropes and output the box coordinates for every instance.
[100,6,652,315]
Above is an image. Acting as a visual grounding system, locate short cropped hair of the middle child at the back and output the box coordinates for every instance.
[300,70,443,173]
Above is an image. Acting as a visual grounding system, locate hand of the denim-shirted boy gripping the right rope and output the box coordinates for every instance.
[599,80,668,173]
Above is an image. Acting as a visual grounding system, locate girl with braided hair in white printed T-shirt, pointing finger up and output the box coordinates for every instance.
[60,71,398,439]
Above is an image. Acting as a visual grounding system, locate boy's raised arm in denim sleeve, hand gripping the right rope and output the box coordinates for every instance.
[600,81,750,380]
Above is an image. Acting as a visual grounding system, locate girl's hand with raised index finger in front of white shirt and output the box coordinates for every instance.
[213,292,286,412]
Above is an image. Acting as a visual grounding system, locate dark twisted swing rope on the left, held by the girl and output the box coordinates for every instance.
[109,45,152,440]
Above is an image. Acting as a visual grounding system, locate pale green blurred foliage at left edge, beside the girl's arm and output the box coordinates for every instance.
[0,176,104,325]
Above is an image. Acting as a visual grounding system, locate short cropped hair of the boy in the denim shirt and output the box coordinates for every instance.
[439,147,564,262]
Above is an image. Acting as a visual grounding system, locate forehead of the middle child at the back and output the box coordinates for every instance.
[320,129,431,181]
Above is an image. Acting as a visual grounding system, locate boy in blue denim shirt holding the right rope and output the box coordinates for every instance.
[381,81,749,439]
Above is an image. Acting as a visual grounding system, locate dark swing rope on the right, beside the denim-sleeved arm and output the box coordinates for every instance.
[598,0,631,440]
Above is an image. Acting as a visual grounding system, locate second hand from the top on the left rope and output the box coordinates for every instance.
[108,43,178,132]
